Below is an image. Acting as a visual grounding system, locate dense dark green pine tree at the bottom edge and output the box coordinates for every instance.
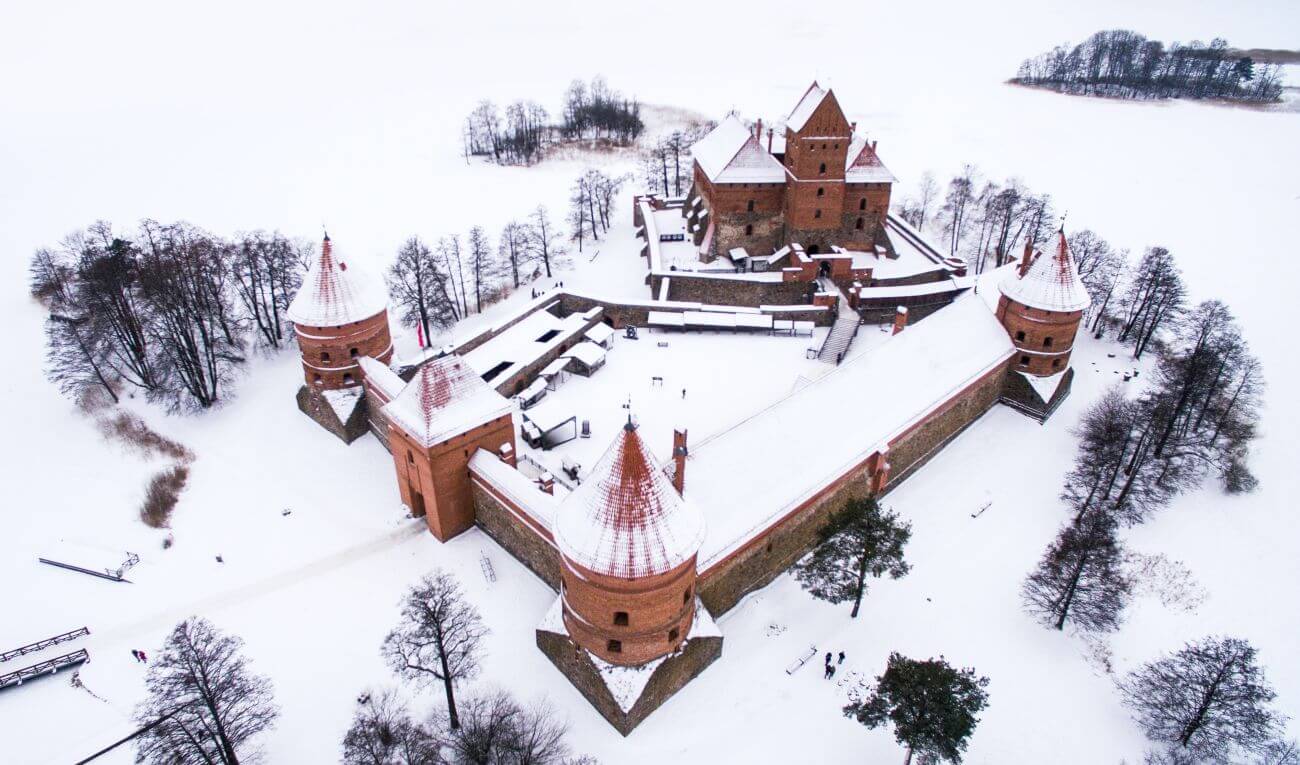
[844,653,988,765]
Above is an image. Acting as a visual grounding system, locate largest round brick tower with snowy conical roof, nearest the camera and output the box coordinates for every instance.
[554,420,705,666]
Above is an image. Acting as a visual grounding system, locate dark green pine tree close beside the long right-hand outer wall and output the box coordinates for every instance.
[794,497,911,618]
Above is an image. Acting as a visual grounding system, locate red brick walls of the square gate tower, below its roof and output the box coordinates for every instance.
[389,415,516,541]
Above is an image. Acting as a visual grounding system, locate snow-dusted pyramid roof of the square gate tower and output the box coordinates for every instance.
[384,355,511,448]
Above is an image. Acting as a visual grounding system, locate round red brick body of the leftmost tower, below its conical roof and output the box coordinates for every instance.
[294,311,393,390]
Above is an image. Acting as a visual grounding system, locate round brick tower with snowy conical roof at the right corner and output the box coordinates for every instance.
[997,230,1092,377]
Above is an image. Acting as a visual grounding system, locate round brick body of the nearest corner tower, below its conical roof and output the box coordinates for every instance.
[560,557,696,665]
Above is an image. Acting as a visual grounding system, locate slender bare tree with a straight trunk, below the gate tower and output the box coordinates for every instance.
[382,571,488,730]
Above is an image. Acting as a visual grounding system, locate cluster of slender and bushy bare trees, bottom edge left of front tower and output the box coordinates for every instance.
[343,571,582,765]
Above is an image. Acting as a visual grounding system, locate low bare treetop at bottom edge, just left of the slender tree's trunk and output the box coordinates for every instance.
[343,688,445,765]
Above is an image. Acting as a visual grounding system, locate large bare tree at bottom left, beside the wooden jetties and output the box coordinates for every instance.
[135,617,280,765]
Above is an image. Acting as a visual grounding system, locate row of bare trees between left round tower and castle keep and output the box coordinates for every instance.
[387,206,567,338]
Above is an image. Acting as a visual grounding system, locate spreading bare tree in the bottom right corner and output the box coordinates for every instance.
[1119,638,1286,762]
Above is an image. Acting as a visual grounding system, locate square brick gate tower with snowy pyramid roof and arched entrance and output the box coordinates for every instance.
[382,355,515,541]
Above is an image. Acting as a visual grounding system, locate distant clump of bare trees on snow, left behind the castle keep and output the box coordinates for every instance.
[464,77,645,165]
